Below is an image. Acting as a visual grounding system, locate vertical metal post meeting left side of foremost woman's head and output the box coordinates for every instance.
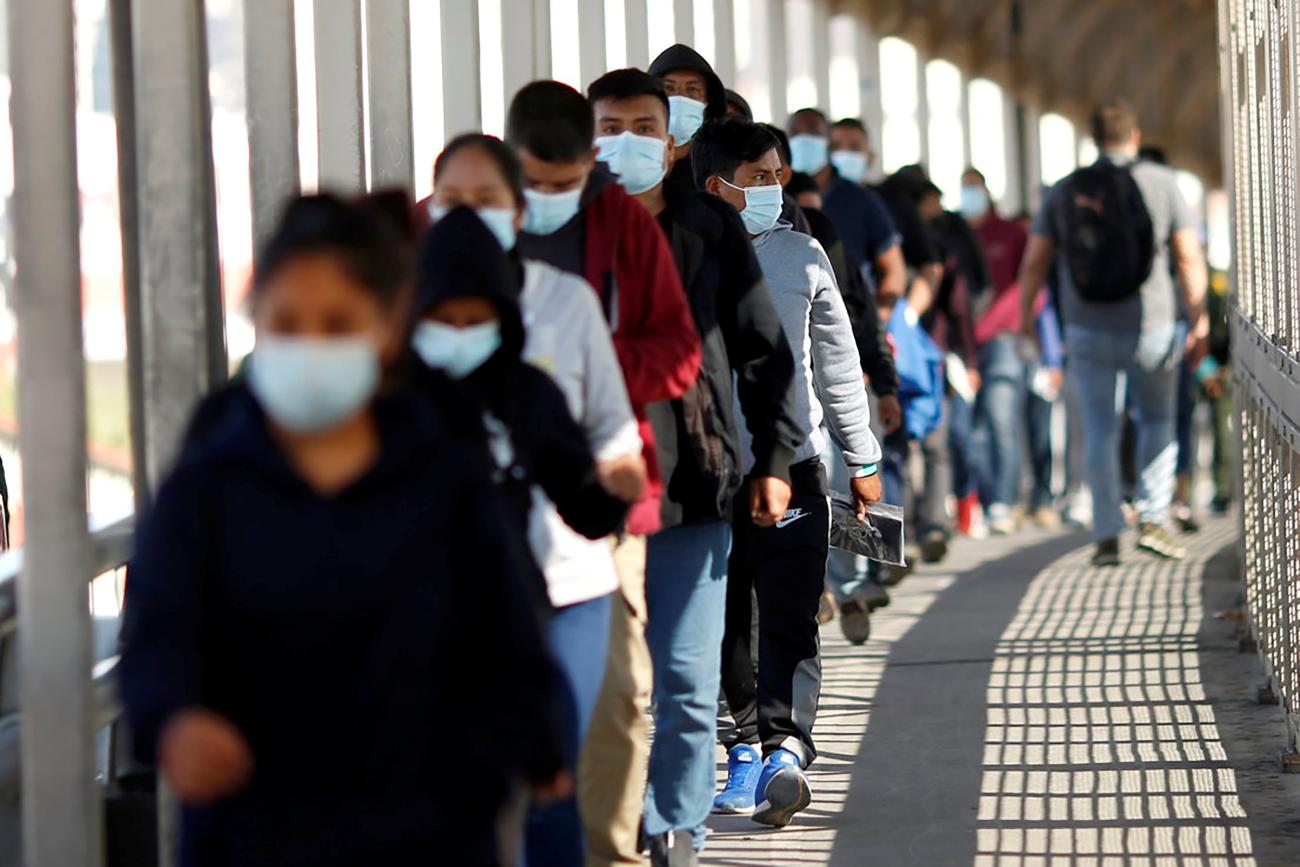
[244,3,299,250]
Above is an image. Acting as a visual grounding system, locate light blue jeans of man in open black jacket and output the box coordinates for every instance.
[647,521,732,847]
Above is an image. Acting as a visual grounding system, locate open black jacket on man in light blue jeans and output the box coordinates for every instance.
[650,181,801,526]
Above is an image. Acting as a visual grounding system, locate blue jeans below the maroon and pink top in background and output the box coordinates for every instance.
[971,334,1026,507]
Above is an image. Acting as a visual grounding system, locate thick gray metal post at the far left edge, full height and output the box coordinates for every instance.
[8,0,103,867]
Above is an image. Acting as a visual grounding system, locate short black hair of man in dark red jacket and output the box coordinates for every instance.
[506,81,595,162]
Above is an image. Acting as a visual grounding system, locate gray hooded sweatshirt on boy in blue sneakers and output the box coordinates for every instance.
[736,221,880,472]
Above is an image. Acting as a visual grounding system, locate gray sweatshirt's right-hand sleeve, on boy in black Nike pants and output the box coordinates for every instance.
[809,242,880,467]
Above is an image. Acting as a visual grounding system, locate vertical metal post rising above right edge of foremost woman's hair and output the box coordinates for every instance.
[365,0,415,191]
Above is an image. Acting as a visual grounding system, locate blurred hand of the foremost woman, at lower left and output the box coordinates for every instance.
[159,707,254,806]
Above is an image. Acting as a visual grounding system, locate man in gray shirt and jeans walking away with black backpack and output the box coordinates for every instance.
[1021,100,1209,565]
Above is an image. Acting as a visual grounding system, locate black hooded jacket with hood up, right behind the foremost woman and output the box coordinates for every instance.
[417,208,628,539]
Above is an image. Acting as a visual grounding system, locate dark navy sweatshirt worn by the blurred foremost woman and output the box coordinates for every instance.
[118,382,562,867]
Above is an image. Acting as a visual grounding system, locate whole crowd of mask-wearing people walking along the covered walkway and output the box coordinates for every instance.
[121,38,1204,867]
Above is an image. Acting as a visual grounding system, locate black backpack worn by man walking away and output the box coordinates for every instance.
[1062,160,1156,304]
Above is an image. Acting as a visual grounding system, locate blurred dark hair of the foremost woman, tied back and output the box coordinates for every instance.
[252,191,413,307]
